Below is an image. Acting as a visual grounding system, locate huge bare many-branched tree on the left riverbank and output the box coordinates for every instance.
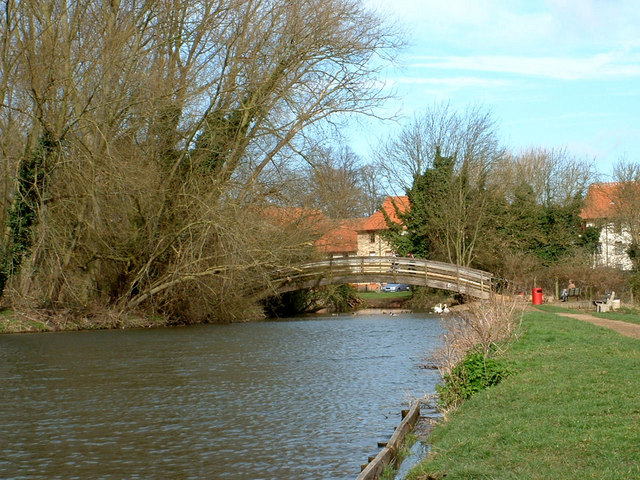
[0,0,395,315]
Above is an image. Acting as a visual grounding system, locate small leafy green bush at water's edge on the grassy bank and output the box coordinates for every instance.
[436,350,509,408]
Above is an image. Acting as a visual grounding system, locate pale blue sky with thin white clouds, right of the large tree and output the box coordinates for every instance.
[351,0,640,180]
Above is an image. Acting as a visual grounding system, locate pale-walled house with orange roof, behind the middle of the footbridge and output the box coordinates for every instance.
[358,196,409,257]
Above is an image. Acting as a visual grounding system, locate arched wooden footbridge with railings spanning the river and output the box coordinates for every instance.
[265,257,493,298]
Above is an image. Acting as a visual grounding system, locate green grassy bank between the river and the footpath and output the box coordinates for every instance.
[408,312,640,480]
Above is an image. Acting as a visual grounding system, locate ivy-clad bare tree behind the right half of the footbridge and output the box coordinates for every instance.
[378,104,504,266]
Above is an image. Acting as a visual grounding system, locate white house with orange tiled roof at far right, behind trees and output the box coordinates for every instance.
[580,182,633,270]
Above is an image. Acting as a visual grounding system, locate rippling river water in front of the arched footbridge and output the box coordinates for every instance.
[0,314,441,480]
